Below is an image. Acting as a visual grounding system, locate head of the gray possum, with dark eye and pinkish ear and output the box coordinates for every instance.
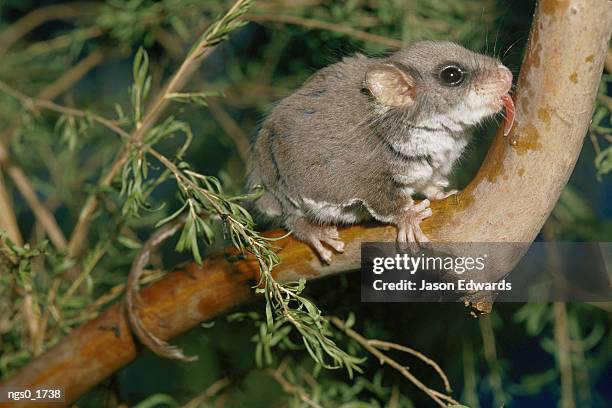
[364,41,512,131]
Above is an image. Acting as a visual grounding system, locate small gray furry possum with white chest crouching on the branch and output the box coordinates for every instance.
[248,41,514,263]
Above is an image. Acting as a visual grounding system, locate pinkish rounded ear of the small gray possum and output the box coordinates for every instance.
[365,64,415,107]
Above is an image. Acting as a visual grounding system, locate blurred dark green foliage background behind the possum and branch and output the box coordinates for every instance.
[0,0,612,407]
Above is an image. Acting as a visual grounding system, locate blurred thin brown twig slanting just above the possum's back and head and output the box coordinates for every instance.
[246,13,406,48]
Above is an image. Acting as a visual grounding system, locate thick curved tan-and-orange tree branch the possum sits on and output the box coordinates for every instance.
[0,0,612,407]
